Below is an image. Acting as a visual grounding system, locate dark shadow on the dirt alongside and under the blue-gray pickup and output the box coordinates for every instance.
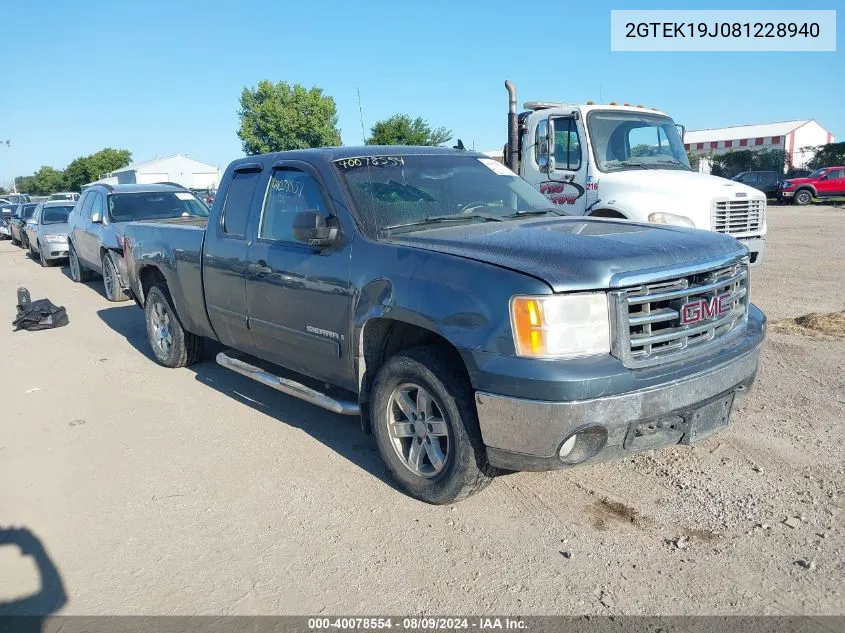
[97,303,399,490]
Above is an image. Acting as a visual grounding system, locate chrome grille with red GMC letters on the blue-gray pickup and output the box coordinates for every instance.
[611,257,749,368]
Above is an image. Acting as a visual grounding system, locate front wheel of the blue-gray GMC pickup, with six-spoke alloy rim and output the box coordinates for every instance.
[370,347,497,504]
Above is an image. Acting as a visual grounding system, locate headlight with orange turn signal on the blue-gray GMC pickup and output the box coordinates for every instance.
[511,292,610,358]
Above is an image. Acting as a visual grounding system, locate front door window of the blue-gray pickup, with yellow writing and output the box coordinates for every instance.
[258,167,328,243]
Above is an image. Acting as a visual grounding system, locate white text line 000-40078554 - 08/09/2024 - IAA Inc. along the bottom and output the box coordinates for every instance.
[308,616,528,631]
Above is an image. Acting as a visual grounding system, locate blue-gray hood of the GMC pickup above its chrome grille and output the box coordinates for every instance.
[388,217,747,292]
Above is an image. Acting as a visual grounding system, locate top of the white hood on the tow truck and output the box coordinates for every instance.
[599,169,764,201]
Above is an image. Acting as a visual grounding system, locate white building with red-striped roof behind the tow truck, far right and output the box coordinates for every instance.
[684,119,834,171]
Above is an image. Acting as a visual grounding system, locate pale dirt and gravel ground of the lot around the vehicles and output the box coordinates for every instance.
[0,206,845,615]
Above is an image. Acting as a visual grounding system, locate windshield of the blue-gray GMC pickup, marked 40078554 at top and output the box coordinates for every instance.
[334,154,565,235]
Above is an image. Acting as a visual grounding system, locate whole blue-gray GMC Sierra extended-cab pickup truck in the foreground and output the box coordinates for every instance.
[124,147,765,503]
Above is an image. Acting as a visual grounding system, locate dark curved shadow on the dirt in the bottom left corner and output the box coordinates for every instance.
[0,527,67,633]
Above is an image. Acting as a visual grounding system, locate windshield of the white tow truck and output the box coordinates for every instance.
[588,110,690,172]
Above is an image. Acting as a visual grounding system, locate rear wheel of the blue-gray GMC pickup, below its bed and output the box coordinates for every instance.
[144,284,203,367]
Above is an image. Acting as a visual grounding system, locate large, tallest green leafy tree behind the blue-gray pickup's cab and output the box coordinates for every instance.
[238,80,341,155]
